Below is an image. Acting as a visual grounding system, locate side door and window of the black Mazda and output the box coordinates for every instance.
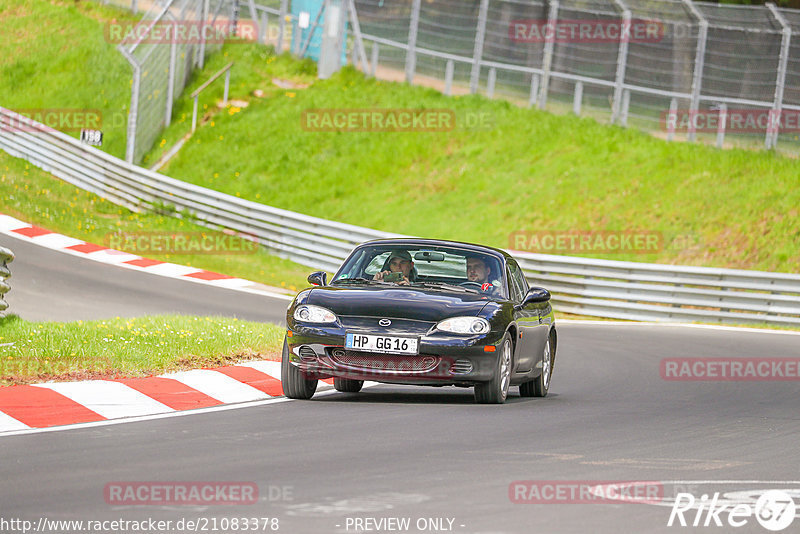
[508,259,549,373]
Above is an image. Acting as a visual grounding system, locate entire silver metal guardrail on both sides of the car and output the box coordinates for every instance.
[0,108,800,326]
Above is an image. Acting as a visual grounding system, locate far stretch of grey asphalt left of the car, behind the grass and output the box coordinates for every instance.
[0,235,289,323]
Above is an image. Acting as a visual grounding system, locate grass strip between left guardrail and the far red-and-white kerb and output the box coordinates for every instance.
[0,151,312,292]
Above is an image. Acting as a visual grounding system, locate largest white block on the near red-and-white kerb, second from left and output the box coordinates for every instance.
[32,380,174,419]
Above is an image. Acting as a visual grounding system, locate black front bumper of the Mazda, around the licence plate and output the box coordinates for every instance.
[287,325,503,386]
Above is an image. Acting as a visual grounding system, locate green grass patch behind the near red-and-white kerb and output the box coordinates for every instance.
[0,315,284,385]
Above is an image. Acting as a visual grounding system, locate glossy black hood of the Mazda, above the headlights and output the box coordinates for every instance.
[306,287,490,322]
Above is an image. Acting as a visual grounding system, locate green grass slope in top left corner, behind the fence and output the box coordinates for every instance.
[0,0,140,157]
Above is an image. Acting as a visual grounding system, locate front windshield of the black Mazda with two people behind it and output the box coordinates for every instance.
[331,244,507,298]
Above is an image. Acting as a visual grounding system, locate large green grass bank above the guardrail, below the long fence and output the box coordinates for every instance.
[141,45,800,272]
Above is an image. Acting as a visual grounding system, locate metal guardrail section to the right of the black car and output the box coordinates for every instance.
[514,252,800,326]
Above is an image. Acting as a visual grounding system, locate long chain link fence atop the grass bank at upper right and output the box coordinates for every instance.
[355,0,800,152]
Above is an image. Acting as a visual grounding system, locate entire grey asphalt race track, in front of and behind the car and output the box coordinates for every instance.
[0,234,800,533]
